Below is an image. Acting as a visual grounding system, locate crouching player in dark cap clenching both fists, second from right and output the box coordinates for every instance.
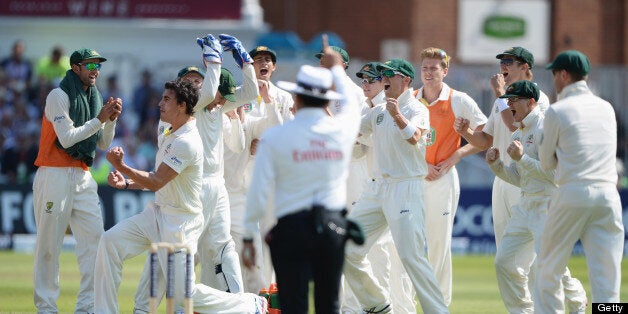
[486,80,587,313]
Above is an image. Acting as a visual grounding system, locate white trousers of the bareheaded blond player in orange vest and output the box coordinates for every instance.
[423,167,460,306]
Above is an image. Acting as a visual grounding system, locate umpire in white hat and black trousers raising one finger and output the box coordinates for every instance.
[242,40,360,314]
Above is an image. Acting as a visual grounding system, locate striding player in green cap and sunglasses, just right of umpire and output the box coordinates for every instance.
[344,59,449,313]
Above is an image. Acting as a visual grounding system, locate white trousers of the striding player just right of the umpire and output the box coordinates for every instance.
[344,178,449,313]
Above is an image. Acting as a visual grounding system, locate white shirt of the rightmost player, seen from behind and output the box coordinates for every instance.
[539,81,617,186]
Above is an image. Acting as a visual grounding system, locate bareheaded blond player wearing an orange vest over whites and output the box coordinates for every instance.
[416,47,486,306]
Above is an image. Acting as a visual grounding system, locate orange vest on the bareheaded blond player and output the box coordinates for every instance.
[417,89,460,165]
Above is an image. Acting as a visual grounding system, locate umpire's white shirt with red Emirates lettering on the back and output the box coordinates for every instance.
[245,66,360,237]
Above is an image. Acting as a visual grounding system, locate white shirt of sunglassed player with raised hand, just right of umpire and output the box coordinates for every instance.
[360,88,430,178]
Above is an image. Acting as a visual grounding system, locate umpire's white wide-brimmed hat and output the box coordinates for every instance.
[277,65,343,100]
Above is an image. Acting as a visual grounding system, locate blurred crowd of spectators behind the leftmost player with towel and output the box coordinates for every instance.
[0,40,161,184]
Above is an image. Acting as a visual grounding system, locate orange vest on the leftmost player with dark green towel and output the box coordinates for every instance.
[35,116,89,171]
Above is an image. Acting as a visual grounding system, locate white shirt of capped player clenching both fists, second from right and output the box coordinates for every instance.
[490,106,556,197]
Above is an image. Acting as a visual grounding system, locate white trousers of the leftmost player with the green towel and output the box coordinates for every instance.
[33,167,104,313]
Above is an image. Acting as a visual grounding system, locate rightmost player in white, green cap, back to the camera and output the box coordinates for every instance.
[534,50,624,313]
